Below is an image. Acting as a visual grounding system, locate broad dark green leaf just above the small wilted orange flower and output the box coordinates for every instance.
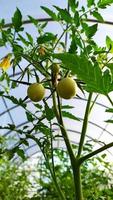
[37,32,56,44]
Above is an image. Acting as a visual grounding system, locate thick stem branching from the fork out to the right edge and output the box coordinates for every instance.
[79,142,113,164]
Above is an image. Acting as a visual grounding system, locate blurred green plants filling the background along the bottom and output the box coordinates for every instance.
[0,137,113,200]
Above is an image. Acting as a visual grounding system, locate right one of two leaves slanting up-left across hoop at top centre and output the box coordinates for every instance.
[54,6,72,23]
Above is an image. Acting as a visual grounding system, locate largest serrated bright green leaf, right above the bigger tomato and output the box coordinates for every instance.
[53,53,113,95]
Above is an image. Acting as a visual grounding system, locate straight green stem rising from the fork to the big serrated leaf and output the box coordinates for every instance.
[77,93,92,157]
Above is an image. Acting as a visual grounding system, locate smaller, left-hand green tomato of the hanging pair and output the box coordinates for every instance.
[27,83,45,102]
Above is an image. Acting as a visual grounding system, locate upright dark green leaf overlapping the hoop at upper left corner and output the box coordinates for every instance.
[12,8,22,32]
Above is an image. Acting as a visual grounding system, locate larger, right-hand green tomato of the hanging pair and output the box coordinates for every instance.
[57,77,77,99]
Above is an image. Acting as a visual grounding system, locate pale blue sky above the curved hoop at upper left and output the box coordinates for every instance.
[0,0,67,22]
